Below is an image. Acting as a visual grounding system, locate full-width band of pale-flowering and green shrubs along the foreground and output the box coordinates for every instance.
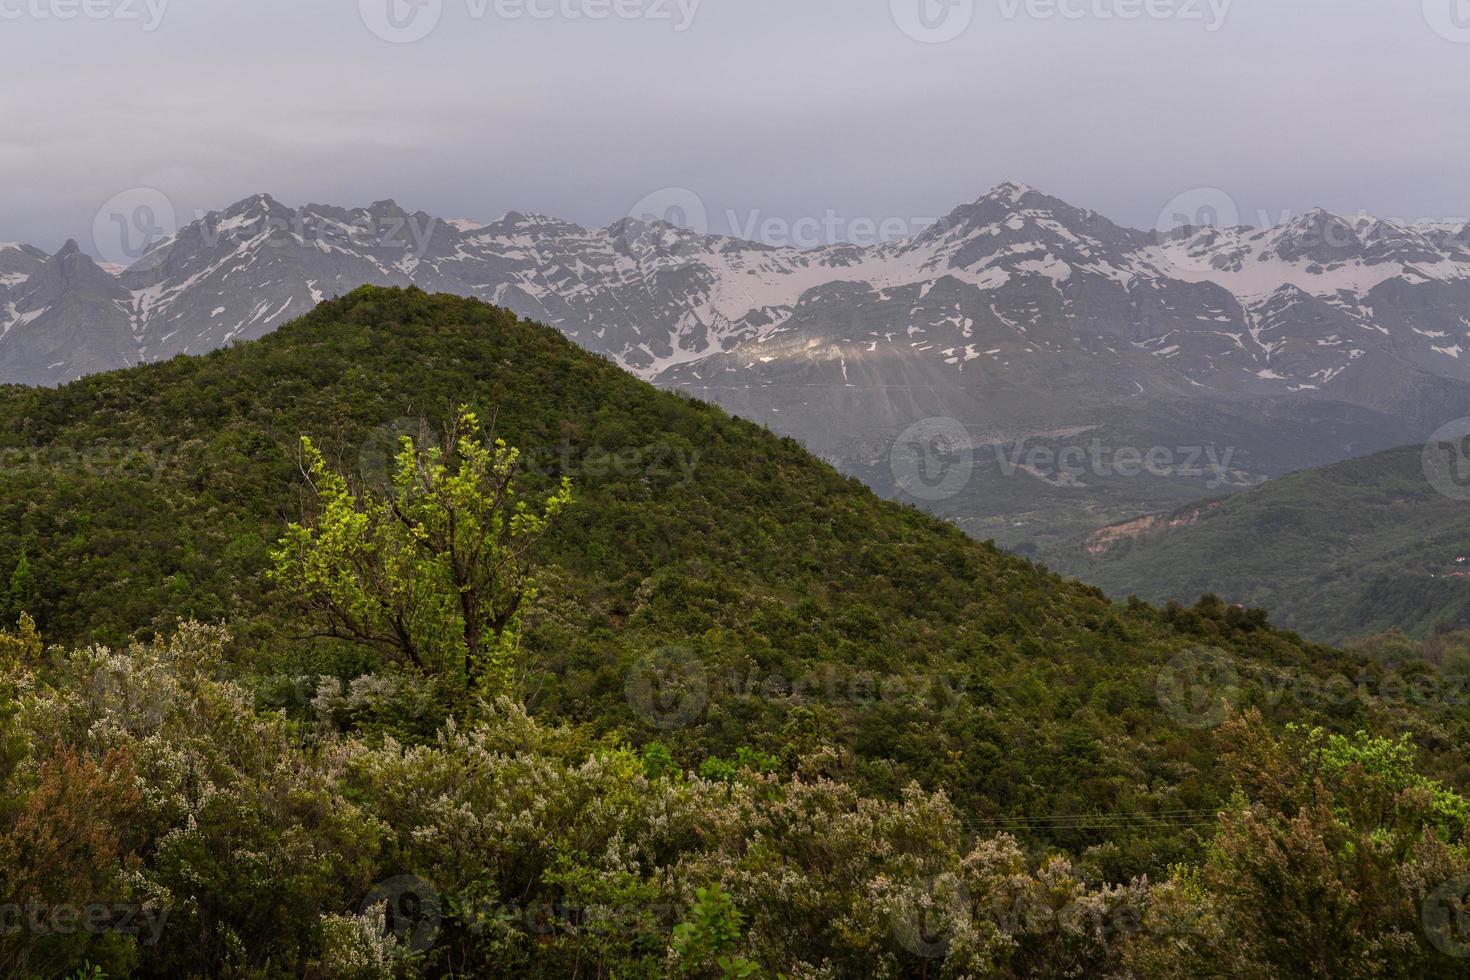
[0,624,1470,977]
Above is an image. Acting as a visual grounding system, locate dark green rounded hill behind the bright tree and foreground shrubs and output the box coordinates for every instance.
[0,289,1464,834]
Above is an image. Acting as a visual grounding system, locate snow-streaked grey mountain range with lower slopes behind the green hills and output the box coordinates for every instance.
[0,184,1470,550]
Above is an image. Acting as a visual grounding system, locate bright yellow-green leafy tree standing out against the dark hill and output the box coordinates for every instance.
[272,408,572,691]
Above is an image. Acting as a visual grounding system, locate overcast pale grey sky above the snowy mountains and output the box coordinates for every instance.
[0,0,1470,251]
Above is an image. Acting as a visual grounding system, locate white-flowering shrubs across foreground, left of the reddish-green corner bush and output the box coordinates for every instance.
[3,624,1147,979]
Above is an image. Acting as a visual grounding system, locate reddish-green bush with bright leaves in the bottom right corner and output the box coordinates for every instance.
[1127,714,1470,977]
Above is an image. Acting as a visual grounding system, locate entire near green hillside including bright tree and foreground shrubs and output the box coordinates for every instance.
[0,288,1470,977]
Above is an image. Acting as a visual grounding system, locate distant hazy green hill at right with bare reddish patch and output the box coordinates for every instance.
[1045,447,1470,642]
